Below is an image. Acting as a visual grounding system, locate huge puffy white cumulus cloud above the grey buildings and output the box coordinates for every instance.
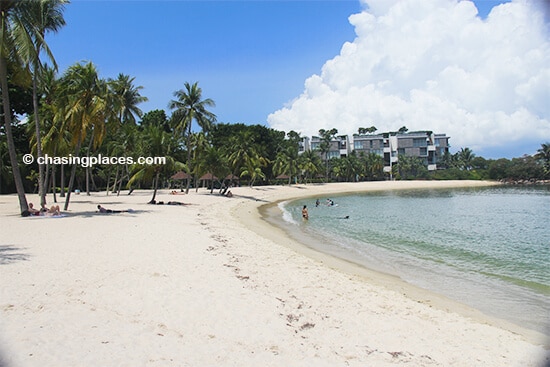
[268,0,550,154]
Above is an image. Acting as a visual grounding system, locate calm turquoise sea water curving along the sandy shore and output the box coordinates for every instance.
[280,186,550,335]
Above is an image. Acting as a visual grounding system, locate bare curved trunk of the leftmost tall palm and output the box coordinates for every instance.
[0,56,29,214]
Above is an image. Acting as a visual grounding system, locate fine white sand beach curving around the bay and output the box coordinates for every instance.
[0,181,550,367]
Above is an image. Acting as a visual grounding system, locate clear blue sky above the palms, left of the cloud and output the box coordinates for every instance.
[47,0,550,157]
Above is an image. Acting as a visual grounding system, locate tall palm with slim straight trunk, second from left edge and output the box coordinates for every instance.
[25,0,68,204]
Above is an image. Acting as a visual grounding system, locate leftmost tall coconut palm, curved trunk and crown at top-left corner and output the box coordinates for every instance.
[0,0,35,214]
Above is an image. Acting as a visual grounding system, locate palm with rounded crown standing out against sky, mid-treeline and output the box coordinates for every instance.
[168,82,216,193]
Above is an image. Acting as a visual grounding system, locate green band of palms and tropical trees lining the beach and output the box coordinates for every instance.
[0,0,550,213]
